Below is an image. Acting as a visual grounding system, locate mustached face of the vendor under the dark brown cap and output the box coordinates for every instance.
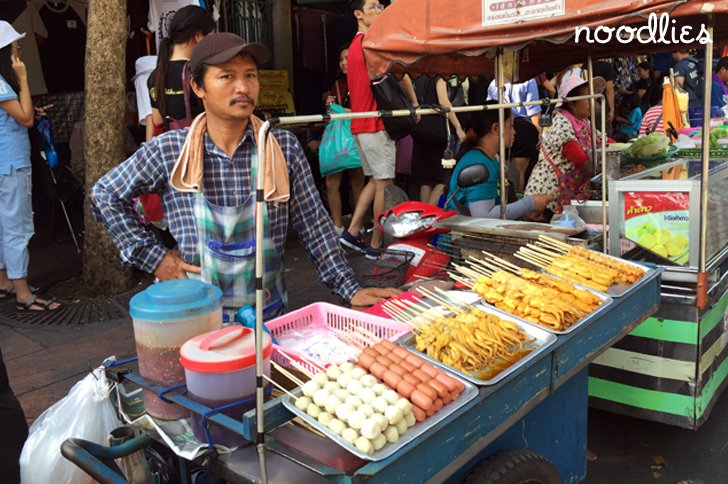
[192,54,260,120]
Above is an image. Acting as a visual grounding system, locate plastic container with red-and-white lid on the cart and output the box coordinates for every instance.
[180,326,273,448]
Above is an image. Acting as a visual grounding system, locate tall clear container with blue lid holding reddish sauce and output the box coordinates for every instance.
[129,279,222,420]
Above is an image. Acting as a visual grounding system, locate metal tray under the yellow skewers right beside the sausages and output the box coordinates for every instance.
[395,303,556,386]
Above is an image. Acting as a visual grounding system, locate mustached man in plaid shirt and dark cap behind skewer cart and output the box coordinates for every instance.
[91,34,398,306]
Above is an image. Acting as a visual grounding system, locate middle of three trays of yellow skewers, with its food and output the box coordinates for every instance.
[450,253,612,334]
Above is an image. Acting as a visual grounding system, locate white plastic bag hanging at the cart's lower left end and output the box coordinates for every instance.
[20,367,122,484]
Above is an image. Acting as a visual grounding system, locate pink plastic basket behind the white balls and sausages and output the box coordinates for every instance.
[265,302,409,373]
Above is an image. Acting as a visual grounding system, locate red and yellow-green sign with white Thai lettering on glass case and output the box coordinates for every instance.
[624,192,690,265]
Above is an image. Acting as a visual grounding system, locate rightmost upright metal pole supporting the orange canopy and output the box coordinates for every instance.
[696,15,713,309]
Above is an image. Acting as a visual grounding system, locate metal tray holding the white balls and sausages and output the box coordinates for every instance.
[281,374,478,461]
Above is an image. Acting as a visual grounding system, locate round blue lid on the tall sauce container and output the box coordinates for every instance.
[129,279,222,322]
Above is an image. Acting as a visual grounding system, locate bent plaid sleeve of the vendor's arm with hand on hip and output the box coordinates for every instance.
[89,138,167,273]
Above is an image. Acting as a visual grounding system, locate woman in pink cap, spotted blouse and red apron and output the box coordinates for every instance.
[525,69,605,220]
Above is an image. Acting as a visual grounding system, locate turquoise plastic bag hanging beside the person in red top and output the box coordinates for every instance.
[319,104,361,176]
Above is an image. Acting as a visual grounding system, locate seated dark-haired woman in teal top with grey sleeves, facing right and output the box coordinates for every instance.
[446,106,551,220]
